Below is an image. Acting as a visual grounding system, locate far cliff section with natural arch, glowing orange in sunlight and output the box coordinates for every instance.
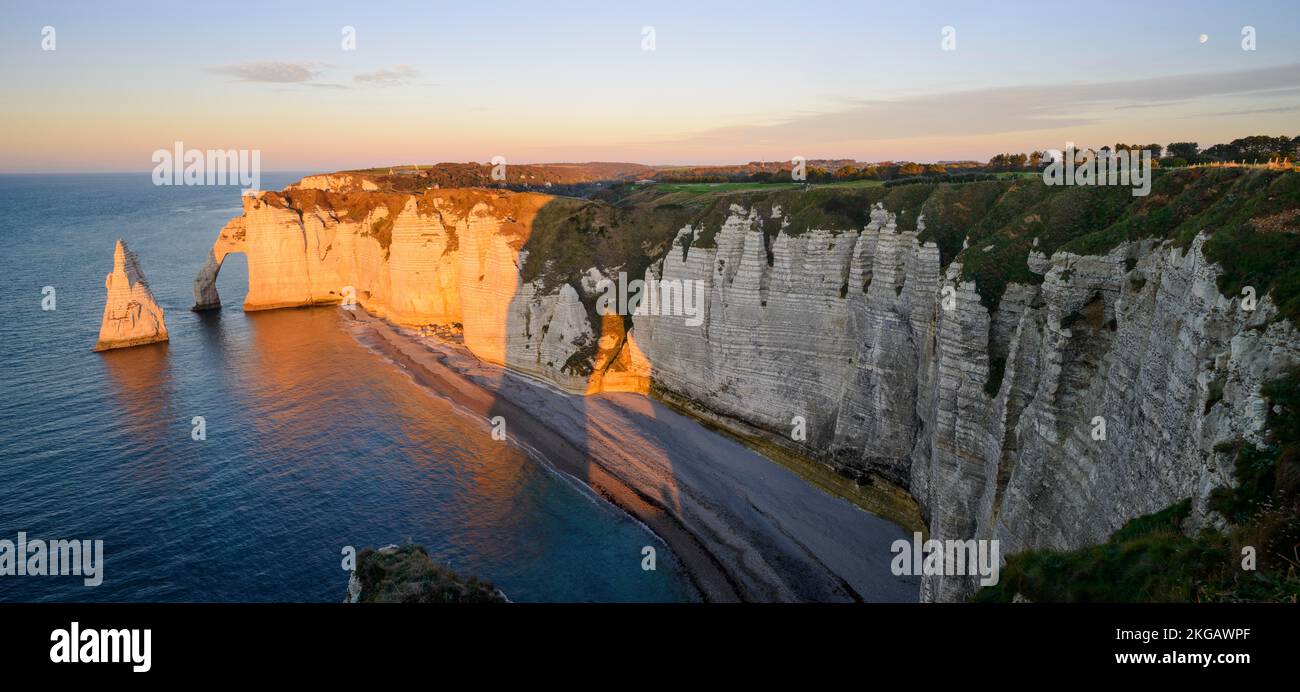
[194,188,649,393]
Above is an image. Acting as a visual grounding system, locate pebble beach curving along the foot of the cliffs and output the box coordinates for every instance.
[348,308,919,602]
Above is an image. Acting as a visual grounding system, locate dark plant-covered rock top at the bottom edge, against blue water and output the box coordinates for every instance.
[347,544,510,604]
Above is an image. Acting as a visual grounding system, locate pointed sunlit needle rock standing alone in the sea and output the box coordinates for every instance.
[94,241,168,351]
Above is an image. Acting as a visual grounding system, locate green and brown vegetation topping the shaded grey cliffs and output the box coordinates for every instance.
[621,168,1300,320]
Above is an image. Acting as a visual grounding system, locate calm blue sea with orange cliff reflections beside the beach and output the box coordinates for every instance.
[0,173,693,601]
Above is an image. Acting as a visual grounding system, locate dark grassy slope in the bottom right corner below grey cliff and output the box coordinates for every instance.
[976,368,1300,604]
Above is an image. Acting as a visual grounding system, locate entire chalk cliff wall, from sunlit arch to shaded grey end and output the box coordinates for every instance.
[195,171,1300,600]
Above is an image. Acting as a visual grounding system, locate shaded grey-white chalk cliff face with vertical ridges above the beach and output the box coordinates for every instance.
[636,196,1300,600]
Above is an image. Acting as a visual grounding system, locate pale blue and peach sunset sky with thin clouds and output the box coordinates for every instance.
[0,0,1300,173]
